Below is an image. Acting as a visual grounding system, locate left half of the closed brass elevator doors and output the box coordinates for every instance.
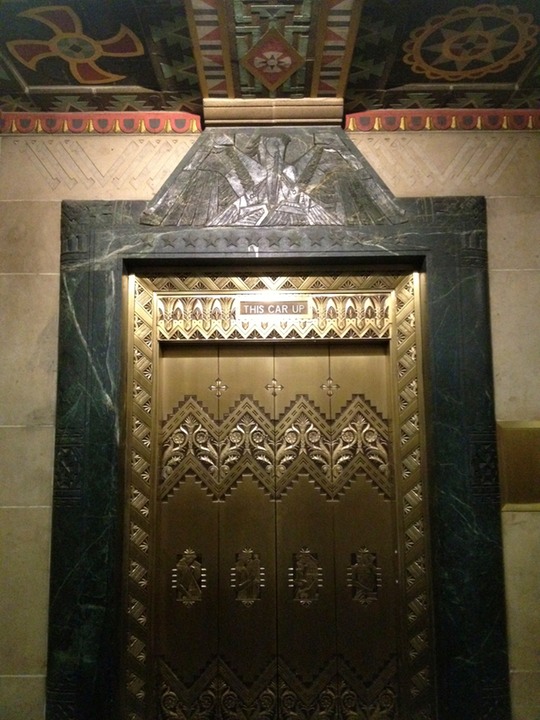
[156,343,276,717]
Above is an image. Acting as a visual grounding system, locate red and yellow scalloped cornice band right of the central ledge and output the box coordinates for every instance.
[345,108,540,132]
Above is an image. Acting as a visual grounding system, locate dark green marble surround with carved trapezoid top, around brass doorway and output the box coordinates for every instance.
[47,128,509,720]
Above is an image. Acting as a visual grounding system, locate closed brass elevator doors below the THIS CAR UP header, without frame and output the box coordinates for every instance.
[153,341,399,720]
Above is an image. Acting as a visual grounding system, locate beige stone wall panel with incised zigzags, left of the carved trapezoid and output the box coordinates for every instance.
[0,134,199,200]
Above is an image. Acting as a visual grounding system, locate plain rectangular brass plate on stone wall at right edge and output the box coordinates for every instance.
[497,420,540,506]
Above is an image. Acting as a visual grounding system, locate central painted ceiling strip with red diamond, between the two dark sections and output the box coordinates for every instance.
[187,0,363,99]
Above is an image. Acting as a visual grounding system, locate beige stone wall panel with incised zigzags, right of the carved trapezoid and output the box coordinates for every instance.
[349,132,540,197]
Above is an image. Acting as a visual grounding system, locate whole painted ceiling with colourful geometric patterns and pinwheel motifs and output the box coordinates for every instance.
[0,0,540,122]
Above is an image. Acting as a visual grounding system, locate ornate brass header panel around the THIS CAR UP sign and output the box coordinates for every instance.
[156,276,393,341]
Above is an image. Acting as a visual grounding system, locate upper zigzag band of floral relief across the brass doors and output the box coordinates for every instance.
[162,396,389,497]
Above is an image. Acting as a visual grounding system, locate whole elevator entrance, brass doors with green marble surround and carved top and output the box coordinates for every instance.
[47,127,509,720]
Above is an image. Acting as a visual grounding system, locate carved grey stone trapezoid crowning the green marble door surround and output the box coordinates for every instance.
[141,128,406,227]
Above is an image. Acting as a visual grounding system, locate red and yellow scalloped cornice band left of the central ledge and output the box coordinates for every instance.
[0,111,202,135]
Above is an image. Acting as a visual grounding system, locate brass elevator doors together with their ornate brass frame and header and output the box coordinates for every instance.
[122,271,435,720]
